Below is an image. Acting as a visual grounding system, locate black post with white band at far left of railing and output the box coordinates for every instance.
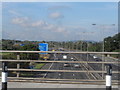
[1,62,7,90]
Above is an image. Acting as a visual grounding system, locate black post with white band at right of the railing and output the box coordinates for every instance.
[106,64,112,90]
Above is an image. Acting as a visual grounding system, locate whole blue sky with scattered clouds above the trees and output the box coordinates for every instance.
[2,2,118,41]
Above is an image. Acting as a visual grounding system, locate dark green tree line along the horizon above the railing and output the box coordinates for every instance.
[0,33,120,52]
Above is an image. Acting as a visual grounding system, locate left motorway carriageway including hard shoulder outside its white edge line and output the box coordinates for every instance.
[37,54,88,79]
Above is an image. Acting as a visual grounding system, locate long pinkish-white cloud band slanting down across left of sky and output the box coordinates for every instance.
[12,17,66,33]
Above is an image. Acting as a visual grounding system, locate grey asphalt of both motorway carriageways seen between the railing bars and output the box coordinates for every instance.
[39,54,118,80]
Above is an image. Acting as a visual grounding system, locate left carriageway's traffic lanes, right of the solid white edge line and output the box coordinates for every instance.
[46,54,87,79]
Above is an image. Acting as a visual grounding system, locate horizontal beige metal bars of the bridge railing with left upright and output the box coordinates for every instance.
[0,50,120,83]
